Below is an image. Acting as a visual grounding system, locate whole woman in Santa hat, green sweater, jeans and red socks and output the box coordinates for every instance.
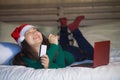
[11,16,93,69]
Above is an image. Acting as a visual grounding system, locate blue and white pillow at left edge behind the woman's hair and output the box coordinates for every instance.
[0,42,20,65]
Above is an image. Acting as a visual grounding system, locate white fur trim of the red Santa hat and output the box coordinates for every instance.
[18,25,34,45]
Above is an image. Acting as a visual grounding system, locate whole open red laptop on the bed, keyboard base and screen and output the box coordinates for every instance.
[71,40,110,68]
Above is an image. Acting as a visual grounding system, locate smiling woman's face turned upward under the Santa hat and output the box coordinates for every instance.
[25,28,43,46]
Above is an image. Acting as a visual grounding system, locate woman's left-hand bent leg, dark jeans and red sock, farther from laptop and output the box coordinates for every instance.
[59,18,86,61]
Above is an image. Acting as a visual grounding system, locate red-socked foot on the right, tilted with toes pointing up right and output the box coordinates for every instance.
[68,16,85,31]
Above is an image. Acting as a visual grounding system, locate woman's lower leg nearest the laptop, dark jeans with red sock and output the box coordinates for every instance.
[68,16,93,59]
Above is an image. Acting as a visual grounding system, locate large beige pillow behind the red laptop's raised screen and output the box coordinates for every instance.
[80,21,120,48]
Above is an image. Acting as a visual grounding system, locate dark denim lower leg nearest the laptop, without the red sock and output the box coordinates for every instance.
[72,29,94,59]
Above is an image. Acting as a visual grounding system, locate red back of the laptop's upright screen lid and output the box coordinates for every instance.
[93,41,110,67]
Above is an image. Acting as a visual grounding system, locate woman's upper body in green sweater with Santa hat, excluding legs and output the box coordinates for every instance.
[11,24,74,69]
